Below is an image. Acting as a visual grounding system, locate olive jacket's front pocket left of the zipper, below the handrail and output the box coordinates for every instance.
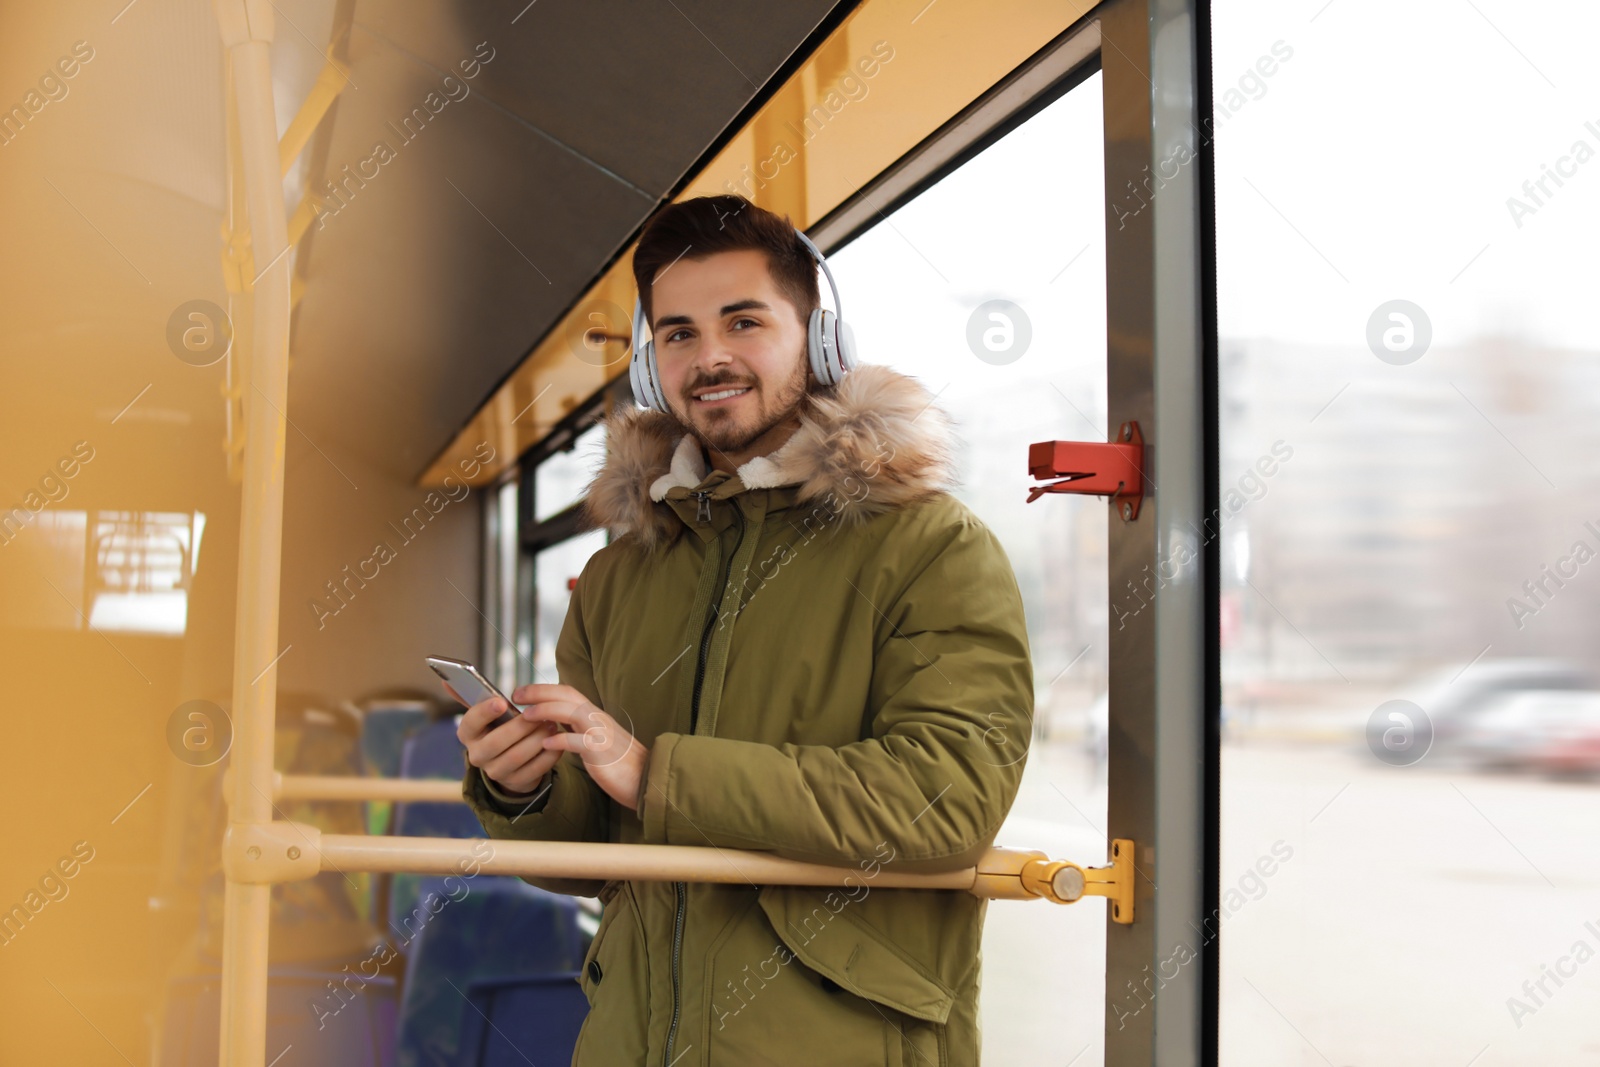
[573,881,650,1065]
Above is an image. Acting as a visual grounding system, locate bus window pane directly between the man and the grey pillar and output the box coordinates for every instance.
[829,74,1107,1067]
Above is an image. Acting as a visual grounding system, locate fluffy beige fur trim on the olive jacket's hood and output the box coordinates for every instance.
[584,363,955,547]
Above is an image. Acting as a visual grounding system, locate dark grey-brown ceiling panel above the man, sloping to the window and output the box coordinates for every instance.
[299,0,835,477]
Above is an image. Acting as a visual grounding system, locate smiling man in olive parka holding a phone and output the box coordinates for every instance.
[459,197,1034,1067]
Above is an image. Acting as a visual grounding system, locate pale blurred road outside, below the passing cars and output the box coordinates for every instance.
[982,731,1600,1067]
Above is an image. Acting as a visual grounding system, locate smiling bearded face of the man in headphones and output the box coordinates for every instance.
[651,250,808,462]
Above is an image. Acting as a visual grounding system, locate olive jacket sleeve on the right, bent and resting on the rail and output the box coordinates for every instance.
[640,518,1034,872]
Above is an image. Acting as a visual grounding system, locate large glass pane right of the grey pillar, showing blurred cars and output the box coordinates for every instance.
[1214,0,1600,1067]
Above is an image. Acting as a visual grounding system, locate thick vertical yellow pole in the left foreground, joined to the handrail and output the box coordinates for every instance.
[216,0,290,1067]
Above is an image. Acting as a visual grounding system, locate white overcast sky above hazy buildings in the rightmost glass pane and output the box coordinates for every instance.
[1214,0,1600,349]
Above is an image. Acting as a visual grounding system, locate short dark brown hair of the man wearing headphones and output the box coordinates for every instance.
[634,194,822,323]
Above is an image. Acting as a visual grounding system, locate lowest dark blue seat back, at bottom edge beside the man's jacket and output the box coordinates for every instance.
[456,971,589,1067]
